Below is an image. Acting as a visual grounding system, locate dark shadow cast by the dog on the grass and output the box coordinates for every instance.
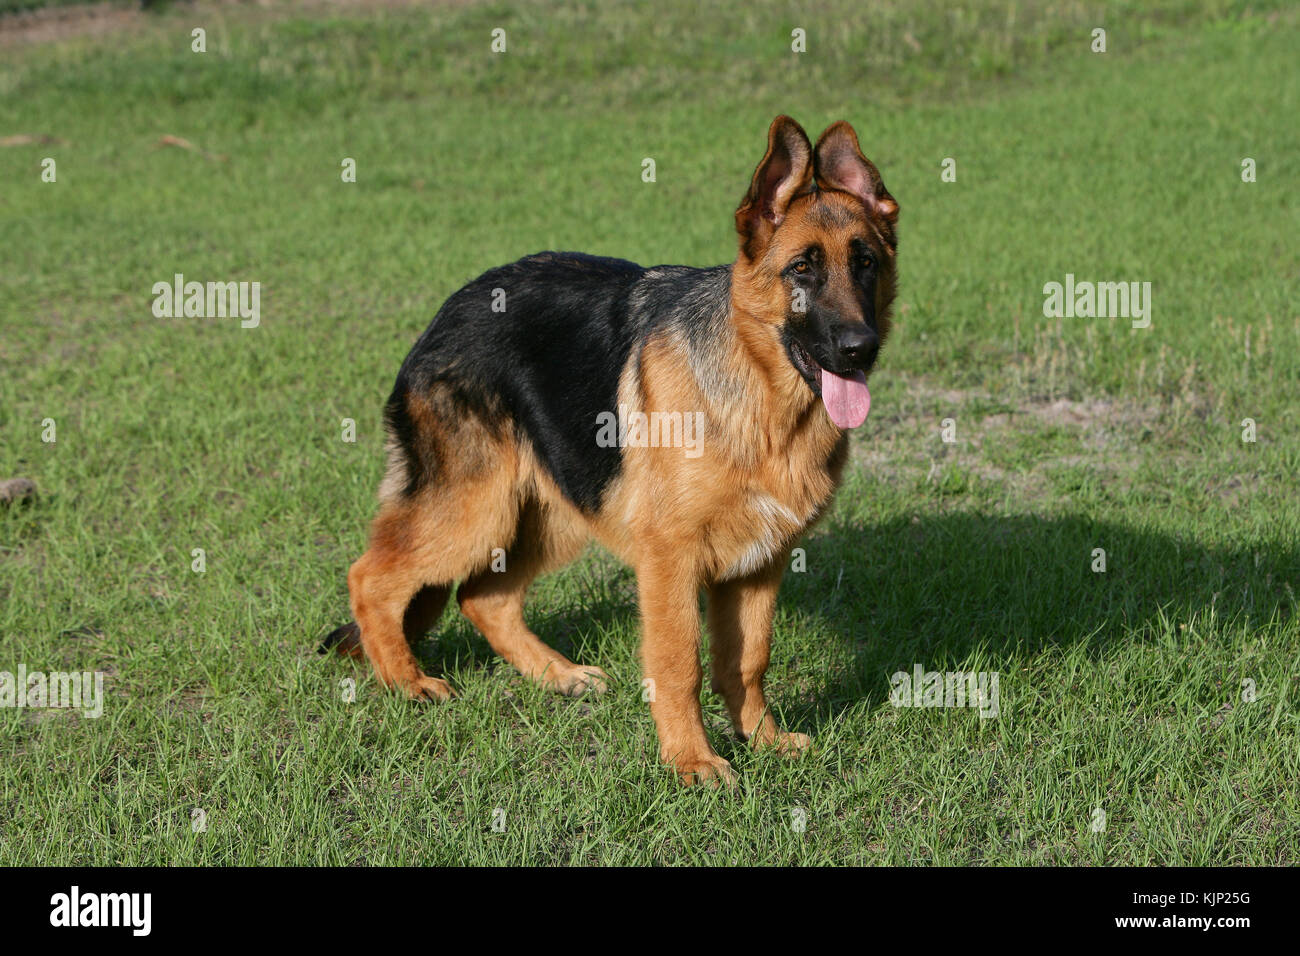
[423,512,1300,732]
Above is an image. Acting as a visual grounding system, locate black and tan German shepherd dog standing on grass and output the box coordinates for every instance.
[322,116,898,783]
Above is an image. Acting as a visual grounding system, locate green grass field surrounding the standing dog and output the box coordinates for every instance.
[0,0,1300,865]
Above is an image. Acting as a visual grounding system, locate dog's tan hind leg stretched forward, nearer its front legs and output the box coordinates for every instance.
[456,499,608,697]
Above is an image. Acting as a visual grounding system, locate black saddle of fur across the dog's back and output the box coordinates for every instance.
[385,252,731,514]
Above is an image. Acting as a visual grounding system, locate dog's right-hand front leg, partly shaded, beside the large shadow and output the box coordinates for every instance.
[709,558,813,756]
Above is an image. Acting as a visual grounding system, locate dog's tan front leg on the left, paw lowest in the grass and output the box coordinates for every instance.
[637,548,735,784]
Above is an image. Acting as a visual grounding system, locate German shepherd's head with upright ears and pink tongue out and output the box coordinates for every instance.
[736,116,898,428]
